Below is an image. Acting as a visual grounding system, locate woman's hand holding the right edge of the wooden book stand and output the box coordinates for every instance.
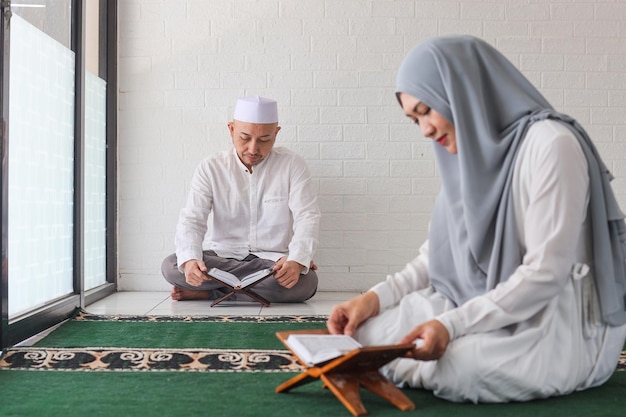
[398,320,450,361]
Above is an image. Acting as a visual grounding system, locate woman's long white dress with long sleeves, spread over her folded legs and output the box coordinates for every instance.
[355,121,626,402]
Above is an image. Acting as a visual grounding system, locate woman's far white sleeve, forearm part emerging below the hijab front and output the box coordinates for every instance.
[370,241,430,311]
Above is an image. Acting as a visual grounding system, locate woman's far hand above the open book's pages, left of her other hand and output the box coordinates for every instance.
[326,291,380,336]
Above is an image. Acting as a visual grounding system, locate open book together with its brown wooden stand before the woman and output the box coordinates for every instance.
[276,329,415,416]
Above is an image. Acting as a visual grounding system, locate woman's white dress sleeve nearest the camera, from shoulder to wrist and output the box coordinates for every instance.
[437,122,589,339]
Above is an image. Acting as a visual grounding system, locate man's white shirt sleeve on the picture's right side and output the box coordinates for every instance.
[287,155,320,274]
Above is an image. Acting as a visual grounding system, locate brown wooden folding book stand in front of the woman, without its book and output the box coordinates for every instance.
[276,329,415,417]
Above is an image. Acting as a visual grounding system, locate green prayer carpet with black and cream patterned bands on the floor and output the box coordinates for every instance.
[0,312,626,417]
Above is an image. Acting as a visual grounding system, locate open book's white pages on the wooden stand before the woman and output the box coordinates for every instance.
[285,333,362,366]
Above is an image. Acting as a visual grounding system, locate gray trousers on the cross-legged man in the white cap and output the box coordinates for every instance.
[161,250,317,303]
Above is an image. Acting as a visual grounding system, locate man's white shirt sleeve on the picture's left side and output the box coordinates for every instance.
[174,161,213,272]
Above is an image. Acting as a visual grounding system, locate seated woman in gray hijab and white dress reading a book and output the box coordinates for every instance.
[327,36,626,402]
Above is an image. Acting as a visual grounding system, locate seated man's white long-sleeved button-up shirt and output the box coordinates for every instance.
[175,147,320,274]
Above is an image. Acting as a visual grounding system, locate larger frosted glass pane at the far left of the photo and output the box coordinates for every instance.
[7,14,75,317]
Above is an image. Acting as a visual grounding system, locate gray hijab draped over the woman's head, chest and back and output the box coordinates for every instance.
[396,36,626,325]
